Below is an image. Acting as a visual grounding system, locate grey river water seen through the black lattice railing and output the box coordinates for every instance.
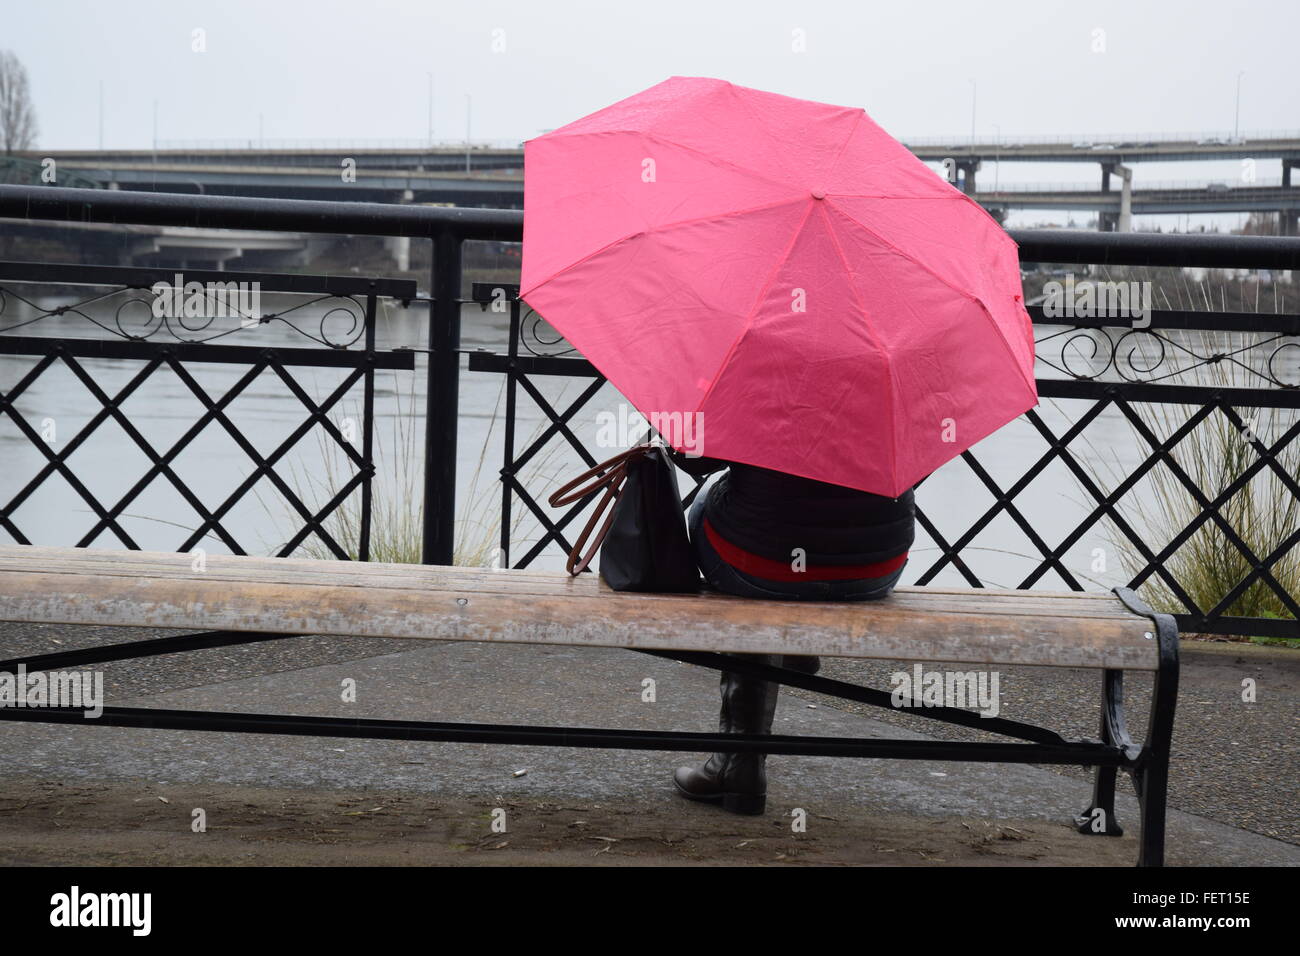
[0,295,1300,588]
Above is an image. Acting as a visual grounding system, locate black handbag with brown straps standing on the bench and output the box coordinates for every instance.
[550,445,699,593]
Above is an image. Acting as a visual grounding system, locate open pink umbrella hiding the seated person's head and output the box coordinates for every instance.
[521,77,1037,497]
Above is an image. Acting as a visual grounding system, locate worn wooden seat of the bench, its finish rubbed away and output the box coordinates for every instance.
[0,545,1156,670]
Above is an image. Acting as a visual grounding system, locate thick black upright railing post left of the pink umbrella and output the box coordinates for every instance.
[423,228,460,564]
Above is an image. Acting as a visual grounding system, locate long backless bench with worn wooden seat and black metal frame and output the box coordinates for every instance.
[0,545,1178,866]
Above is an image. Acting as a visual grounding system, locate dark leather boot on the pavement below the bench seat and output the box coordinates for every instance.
[672,654,781,814]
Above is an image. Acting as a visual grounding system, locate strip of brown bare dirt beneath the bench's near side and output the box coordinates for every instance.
[0,779,1159,866]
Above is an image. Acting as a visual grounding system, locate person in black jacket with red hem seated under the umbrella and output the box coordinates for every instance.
[671,451,915,814]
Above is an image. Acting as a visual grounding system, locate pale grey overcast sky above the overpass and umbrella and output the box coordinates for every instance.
[0,0,1300,225]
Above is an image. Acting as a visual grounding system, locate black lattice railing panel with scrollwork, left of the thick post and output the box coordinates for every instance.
[0,254,416,561]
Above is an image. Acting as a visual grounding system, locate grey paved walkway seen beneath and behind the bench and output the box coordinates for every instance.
[0,626,1300,865]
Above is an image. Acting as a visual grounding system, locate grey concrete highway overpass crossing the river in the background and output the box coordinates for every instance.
[10,131,1300,234]
